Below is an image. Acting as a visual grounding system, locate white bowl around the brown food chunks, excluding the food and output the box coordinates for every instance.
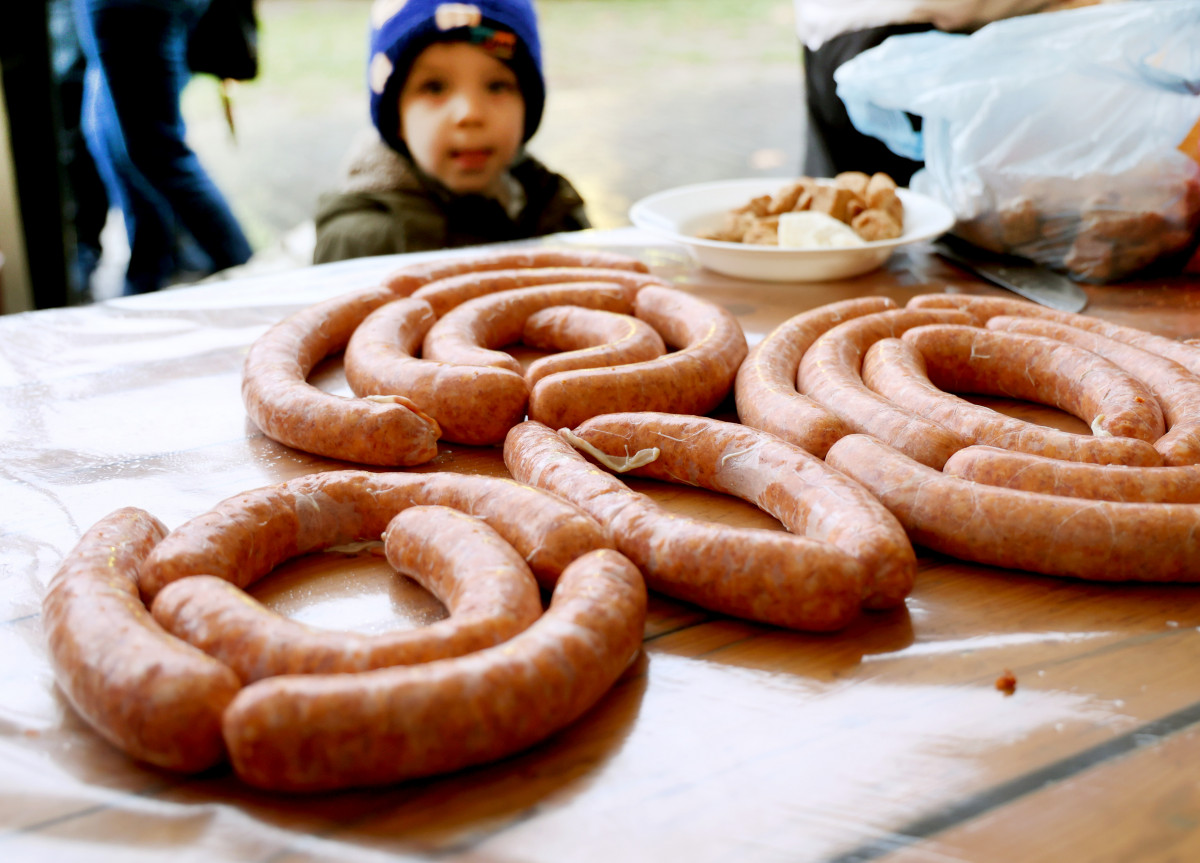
[629,176,954,282]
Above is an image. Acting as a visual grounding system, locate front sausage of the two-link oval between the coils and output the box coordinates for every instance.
[504,421,866,630]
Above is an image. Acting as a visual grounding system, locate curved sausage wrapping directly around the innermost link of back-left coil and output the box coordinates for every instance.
[421,282,636,374]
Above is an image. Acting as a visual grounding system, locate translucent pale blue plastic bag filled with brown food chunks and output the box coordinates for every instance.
[834,0,1200,282]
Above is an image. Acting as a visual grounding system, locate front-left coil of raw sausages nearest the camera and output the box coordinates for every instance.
[43,471,646,791]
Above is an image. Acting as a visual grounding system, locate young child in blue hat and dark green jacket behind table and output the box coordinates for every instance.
[313,0,589,263]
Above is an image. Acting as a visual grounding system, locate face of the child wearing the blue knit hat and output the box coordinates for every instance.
[400,42,524,194]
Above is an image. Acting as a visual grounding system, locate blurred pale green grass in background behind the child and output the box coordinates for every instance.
[184,0,798,121]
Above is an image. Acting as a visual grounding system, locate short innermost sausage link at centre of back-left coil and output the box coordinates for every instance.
[521,306,667,388]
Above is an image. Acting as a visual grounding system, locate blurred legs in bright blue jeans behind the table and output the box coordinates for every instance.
[73,0,252,294]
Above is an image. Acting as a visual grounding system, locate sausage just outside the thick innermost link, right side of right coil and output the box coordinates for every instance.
[988,316,1200,465]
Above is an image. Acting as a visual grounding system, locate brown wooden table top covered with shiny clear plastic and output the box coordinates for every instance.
[7,229,1200,863]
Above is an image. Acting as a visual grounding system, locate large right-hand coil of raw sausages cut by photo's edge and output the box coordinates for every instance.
[734,294,1200,586]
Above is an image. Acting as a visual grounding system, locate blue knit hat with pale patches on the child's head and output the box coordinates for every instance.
[367,0,546,154]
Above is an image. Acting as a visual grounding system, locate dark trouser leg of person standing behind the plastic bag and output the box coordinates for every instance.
[804,24,932,186]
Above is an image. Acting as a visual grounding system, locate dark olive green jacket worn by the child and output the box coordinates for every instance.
[313,139,590,264]
